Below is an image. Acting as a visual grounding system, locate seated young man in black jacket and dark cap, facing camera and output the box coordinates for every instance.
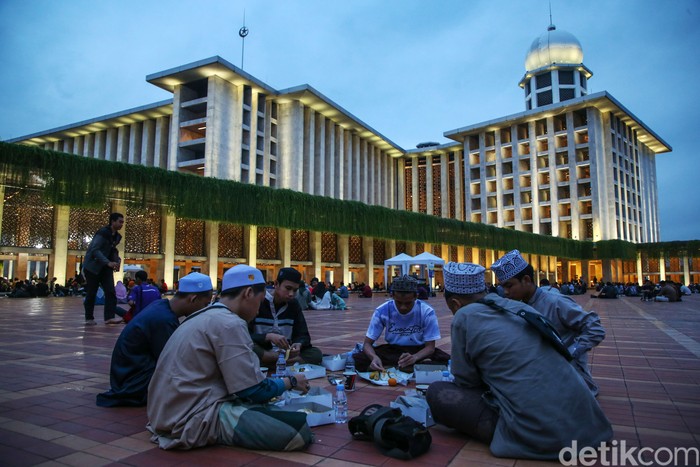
[248,268,323,367]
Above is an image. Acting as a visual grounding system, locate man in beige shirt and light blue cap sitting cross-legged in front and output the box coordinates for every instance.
[147,264,311,451]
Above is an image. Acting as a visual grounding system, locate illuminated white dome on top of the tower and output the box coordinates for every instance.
[525,25,583,71]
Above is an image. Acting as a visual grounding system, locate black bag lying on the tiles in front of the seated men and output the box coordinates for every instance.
[348,404,433,459]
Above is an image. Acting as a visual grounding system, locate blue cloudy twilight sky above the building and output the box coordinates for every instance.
[0,0,700,241]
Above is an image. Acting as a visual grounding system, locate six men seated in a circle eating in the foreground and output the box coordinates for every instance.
[97,258,612,459]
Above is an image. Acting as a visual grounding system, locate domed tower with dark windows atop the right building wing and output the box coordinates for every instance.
[519,22,593,110]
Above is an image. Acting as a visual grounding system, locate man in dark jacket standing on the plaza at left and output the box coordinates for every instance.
[83,212,124,325]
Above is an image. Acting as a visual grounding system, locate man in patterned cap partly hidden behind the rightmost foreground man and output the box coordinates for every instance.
[491,250,605,396]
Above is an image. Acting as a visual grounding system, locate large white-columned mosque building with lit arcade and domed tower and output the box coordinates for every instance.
[0,25,700,284]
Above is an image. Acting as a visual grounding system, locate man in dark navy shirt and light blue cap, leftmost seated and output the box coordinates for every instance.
[97,272,212,407]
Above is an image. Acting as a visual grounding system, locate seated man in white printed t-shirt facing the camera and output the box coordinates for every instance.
[354,275,450,373]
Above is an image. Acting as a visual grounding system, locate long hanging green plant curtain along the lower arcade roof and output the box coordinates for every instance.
[0,142,700,260]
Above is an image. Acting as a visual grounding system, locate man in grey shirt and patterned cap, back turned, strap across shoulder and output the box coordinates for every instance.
[427,262,612,460]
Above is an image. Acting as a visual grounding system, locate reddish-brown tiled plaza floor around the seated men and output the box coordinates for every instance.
[0,294,700,467]
